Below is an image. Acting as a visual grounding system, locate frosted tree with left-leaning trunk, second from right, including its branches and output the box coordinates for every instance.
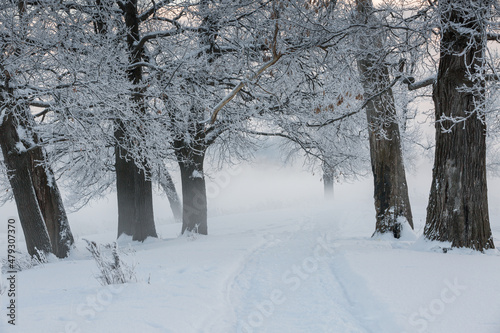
[227,1,421,217]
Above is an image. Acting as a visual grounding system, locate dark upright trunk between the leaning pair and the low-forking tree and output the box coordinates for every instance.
[115,0,157,241]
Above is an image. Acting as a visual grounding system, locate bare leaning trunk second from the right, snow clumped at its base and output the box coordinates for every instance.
[356,0,413,238]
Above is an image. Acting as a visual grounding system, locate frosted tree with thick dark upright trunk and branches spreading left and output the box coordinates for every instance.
[31,0,175,241]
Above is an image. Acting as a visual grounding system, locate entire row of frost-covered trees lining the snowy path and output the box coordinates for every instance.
[0,0,497,257]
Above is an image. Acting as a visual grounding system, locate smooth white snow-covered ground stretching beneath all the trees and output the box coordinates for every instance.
[0,156,500,333]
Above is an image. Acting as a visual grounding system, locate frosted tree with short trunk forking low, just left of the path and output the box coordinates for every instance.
[162,0,274,234]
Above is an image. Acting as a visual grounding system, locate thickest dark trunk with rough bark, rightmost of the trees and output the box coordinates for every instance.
[424,0,494,250]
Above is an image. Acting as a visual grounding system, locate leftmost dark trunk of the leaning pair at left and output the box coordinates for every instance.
[0,112,52,257]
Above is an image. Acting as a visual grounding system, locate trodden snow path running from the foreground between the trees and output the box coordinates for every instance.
[206,208,401,333]
